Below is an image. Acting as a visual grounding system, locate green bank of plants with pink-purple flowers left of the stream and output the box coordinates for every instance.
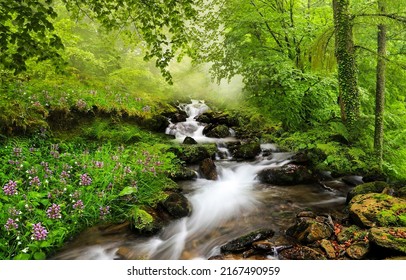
[0,135,177,259]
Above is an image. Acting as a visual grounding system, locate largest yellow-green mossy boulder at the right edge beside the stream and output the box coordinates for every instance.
[349,193,406,228]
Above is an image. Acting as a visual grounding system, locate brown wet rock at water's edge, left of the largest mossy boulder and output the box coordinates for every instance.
[286,214,334,244]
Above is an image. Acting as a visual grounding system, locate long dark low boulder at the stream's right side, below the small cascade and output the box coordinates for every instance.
[258,164,317,186]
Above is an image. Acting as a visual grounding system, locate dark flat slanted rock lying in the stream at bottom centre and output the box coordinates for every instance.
[221,229,275,253]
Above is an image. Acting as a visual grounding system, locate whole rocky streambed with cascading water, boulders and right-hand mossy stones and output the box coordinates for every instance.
[50,101,406,260]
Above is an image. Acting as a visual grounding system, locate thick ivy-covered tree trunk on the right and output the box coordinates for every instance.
[333,0,360,127]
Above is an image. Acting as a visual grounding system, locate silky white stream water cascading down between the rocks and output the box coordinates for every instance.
[50,101,346,260]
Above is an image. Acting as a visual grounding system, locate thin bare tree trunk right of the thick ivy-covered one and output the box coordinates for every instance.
[374,0,386,168]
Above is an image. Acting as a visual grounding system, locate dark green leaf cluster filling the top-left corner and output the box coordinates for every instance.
[0,0,63,73]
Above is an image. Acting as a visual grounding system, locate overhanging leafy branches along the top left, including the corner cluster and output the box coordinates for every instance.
[0,0,201,81]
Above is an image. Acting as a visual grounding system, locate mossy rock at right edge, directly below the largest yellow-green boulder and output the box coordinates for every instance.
[369,227,406,254]
